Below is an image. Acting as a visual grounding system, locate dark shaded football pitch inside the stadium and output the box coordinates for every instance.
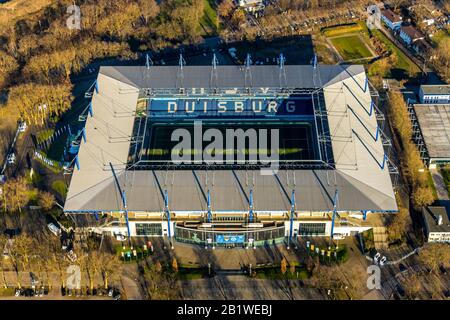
[140,121,319,163]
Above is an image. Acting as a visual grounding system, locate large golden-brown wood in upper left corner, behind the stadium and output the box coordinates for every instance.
[0,0,209,89]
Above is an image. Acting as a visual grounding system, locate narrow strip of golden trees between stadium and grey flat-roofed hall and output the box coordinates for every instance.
[388,91,434,209]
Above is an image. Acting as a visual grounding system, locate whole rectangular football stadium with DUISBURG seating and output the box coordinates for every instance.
[64,59,398,247]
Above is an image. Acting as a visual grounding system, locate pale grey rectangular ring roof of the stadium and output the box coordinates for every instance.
[64,65,397,212]
